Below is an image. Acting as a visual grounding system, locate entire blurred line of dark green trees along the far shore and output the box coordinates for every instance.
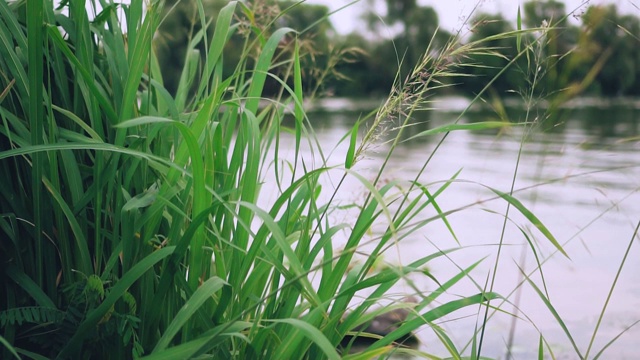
[156,0,640,97]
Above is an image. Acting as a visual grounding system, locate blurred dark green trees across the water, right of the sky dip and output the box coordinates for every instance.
[332,0,640,98]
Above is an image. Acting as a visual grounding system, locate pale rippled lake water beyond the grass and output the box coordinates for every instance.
[268,98,640,359]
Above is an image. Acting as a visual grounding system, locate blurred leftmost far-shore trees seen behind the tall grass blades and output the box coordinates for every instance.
[154,0,336,94]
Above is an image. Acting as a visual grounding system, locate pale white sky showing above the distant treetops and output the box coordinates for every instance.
[307,0,640,34]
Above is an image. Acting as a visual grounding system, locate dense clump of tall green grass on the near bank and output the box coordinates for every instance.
[0,0,636,359]
